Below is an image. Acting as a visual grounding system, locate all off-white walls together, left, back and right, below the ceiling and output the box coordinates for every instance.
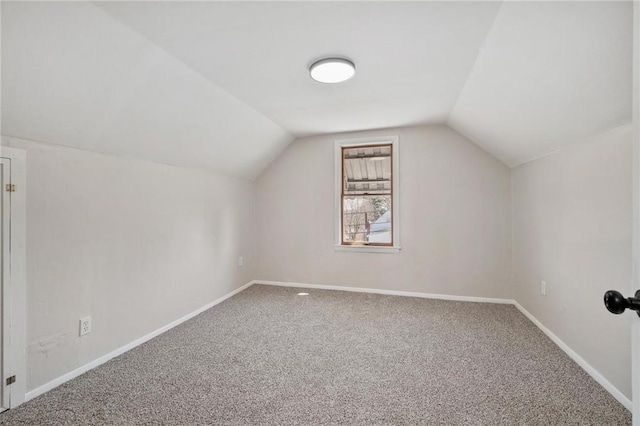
[3,119,631,402]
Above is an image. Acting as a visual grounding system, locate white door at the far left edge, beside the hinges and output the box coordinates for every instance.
[0,158,11,411]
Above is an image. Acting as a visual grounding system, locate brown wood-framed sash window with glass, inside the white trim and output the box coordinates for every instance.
[340,143,393,246]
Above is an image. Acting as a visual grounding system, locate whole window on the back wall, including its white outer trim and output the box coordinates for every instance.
[336,137,399,252]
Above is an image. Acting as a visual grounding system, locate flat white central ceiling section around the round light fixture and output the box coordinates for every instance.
[98,2,499,136]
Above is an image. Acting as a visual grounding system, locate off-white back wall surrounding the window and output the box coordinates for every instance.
[255,126,512,298]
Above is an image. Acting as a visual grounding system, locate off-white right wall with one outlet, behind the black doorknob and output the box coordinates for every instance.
[512,126,637,398]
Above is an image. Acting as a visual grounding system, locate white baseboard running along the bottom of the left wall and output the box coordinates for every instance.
[25,281,255,402]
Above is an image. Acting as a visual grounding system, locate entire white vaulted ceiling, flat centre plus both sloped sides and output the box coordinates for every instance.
[2,1,633,178]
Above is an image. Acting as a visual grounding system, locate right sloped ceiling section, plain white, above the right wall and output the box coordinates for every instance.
[449,2,633,166]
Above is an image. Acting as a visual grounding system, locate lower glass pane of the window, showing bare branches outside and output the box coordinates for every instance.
[342,195,392,244]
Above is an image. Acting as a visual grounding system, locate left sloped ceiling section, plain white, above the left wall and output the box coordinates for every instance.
[2,2,293,178]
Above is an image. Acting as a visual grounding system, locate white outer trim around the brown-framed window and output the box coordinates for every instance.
[334,136,401,253]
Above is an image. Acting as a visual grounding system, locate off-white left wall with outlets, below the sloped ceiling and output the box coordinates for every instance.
[3,138,255,390]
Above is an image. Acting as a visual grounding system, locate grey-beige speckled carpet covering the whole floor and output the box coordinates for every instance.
[0,285,631,425]
